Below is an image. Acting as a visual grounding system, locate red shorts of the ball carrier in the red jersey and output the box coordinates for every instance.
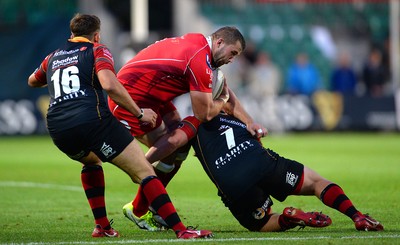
[108,98,176,136]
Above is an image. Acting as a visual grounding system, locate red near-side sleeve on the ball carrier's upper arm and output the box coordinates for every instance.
[188,48,212,93]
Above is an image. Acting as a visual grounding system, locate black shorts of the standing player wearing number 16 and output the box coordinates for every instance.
[50,116,134,162]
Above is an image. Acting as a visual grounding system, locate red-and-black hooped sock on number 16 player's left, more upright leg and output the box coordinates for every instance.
[81,165,111,230]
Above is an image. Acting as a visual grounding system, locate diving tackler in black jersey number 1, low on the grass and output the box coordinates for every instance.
[142,114,383,232]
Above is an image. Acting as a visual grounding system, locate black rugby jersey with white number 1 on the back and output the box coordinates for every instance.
[191,115,275,201]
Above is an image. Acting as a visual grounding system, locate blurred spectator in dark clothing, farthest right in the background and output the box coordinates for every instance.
[362,49,387,97]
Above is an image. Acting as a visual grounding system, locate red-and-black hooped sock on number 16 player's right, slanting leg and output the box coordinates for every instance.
[141,176,186,232]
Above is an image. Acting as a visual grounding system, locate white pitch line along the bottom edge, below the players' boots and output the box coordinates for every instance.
[0,234,400,245]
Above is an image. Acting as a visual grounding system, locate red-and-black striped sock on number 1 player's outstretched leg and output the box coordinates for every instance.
[320,183,358,218]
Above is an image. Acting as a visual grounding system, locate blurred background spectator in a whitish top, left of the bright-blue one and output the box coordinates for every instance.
[248,51,281,99]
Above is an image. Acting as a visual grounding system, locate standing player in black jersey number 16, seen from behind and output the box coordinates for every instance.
[28,14,212,239]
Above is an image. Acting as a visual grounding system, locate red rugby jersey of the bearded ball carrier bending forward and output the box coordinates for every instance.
[117,33,212,103]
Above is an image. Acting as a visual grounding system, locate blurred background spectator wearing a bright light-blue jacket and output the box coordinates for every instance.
[286,52,322,96]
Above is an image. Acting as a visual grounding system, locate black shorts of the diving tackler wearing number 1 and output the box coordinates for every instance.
[223,149,304,231]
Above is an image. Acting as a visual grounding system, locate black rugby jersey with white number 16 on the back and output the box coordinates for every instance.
[46,40,112,132]
